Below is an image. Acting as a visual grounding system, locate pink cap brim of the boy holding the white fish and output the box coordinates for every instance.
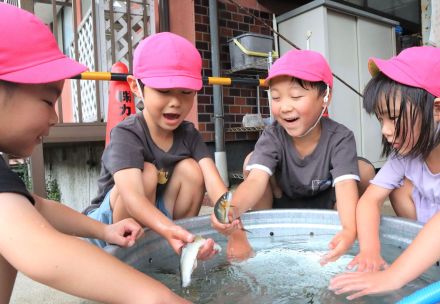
[141,76,203,91]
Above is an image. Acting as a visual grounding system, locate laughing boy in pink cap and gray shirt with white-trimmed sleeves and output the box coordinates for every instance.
[212,50,374,264]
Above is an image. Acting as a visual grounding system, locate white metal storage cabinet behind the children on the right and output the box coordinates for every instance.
[277,0,398,167]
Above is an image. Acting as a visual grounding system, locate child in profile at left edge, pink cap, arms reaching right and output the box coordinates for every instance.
[0,3,188,303]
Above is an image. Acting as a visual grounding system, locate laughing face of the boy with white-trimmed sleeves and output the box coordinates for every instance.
[270,76,324,137]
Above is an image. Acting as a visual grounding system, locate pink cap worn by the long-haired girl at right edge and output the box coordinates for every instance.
[368,46,440,97]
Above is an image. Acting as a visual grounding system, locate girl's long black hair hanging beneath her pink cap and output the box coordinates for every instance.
[363,73,440,159]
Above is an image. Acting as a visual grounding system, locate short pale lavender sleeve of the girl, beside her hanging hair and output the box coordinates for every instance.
[371,156,405,190]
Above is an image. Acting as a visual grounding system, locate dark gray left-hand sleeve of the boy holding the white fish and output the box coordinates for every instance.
[102,126,144,174]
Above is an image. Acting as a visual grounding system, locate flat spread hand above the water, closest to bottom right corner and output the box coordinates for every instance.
[328,270,403,300]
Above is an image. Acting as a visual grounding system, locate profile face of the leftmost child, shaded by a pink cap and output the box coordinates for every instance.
[0,81,64,157]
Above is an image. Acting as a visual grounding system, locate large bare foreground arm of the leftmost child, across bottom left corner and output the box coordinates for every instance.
[0,193,187,303]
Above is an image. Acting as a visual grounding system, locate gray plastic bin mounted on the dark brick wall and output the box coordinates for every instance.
[228,33,273,72]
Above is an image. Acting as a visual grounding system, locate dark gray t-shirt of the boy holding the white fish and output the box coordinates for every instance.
[92,113,210,204]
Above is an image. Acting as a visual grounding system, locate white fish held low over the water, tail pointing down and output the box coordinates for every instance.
[180,235,222,287]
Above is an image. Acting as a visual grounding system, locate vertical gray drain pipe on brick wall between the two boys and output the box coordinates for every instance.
[209,0,229,187]
